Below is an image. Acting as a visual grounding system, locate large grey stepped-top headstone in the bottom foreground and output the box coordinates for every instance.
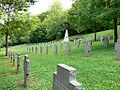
[53,64,82,90]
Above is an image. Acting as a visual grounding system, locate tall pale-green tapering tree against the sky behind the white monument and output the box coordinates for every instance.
[43,0,67,40]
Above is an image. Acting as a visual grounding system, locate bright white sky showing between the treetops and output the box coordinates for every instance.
[29,0,72,15]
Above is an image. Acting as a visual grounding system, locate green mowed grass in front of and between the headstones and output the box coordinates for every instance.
[0,41,120,90]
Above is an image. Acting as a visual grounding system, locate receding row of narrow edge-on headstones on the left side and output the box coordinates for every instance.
[8,52,30,87]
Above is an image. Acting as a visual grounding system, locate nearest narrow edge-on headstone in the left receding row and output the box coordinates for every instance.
[24,55,30,87]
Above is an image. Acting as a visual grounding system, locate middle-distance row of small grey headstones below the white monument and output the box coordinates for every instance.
[27,43,71,55]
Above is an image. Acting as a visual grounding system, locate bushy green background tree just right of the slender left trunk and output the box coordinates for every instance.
[10,13,40,45]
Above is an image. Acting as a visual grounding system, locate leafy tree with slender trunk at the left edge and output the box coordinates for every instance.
[0,0,35,56]
